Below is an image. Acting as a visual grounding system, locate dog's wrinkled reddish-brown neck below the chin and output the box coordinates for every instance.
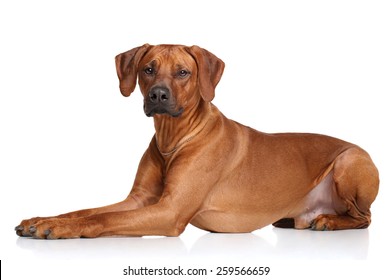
[154,101,212,157]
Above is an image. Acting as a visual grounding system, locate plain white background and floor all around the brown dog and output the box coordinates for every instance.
[0,0,392,279]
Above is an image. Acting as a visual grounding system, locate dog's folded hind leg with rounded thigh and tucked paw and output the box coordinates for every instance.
[310,147,379,230]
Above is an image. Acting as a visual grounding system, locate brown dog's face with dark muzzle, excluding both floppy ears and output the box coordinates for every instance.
[139,46,197,117]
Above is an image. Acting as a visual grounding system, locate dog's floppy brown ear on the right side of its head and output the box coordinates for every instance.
[187,46,225,102]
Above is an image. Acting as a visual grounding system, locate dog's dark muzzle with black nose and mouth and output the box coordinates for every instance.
[144,86,184,117]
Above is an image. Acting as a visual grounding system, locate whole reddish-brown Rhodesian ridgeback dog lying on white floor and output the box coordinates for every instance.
[15,44,379,239]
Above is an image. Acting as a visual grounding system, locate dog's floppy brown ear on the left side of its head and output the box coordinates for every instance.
[116,44,151,97]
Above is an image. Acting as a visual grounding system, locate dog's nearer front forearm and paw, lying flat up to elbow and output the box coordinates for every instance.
[30,203,189,239]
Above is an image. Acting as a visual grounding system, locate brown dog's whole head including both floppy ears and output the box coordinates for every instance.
[116,44,225,117]
